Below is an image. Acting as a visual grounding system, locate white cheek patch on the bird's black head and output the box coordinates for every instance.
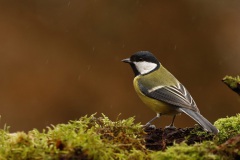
[134,61,157,74]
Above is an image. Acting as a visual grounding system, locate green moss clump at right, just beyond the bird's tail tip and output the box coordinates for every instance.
[214,114,240,144]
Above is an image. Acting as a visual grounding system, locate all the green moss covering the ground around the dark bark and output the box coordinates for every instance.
[0,115,240,160]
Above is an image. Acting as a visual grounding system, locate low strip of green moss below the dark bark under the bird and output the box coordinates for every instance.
[151,141,220,160]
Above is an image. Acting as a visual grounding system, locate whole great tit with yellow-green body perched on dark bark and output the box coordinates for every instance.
[122,51,218,134]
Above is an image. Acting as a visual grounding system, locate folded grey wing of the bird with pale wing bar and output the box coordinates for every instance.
[139,83,199,112]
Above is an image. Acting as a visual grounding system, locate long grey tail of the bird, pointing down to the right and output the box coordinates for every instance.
[180,108,219,134]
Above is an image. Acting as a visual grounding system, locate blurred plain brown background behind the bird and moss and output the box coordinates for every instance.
[0,0,240,131]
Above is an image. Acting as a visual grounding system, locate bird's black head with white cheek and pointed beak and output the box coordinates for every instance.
[122,51,160,76]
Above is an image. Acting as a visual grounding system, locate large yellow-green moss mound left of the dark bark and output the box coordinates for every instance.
[0,115,147,159]
